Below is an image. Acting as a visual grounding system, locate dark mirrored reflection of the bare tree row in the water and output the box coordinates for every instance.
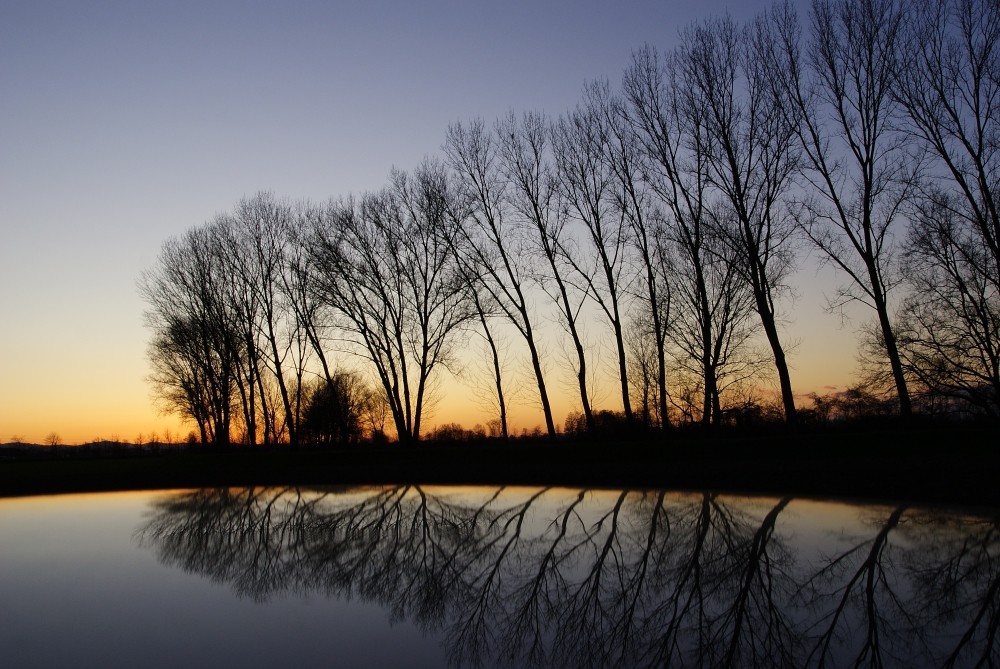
[137,486,1000,667]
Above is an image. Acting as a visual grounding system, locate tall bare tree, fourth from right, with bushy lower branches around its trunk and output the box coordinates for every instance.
[624,47,754,425]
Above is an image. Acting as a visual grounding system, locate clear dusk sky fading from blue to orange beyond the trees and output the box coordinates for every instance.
[0,0,855,443]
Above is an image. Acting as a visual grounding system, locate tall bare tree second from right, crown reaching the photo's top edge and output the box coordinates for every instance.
[758,0,921,416]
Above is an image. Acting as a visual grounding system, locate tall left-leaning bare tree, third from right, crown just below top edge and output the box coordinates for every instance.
[678,18,798,423]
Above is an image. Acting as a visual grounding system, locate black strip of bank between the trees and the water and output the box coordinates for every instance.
[0,426,1000,508]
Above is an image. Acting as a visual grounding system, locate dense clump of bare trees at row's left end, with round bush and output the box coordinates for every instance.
[139,193,384,445]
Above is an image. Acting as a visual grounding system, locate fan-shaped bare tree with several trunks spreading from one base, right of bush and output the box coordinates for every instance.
[310,162,475,443]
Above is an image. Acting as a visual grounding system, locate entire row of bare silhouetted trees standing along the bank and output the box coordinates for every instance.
[140,0,1000,444]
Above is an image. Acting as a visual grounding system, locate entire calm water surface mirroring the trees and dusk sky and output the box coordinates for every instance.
[0,486,1000,667]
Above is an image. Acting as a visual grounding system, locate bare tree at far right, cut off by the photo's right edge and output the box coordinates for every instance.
[897,0,1000,415]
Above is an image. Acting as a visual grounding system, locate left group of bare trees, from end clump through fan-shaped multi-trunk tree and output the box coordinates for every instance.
[140,162,477,445]
